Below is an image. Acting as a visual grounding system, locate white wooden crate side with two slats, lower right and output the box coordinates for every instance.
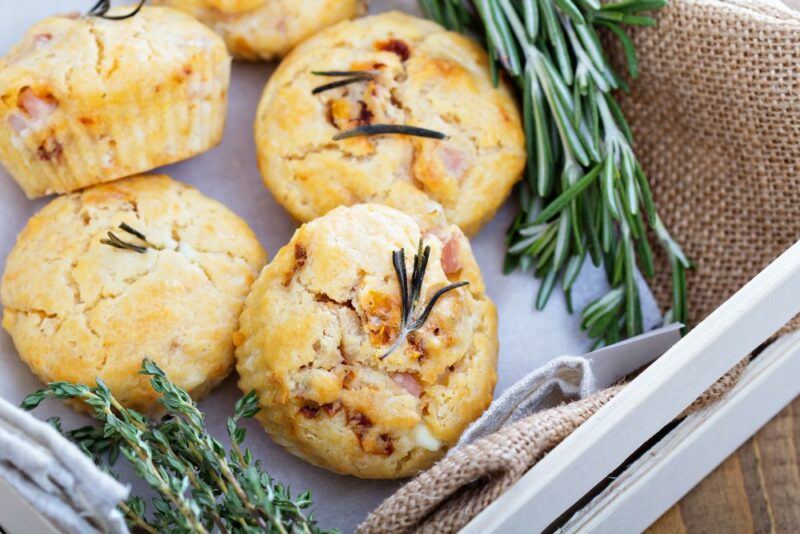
[464,242,800,534]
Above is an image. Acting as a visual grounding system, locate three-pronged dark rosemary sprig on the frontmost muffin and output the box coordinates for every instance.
[381,239,469,360]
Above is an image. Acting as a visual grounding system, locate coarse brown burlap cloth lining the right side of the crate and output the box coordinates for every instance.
[359,0,800,533]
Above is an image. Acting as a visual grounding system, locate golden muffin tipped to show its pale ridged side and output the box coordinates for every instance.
[0,6,230,197]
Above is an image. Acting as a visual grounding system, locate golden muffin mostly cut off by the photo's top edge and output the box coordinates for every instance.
[153,0,366,59]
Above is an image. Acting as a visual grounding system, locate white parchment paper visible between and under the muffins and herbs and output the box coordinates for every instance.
[0,0,660,532]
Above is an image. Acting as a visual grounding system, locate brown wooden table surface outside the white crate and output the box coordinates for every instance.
[649,398,800,534]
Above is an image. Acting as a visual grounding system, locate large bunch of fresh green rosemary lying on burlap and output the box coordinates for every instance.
[420,0,690,345]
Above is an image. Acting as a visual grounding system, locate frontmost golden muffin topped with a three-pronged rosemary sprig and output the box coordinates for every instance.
[234,204,498,478]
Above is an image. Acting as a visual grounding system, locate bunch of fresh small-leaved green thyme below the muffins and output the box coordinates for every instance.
[22,360,332,533]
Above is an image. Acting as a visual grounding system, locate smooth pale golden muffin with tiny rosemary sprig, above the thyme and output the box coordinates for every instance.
[0,175,266,412]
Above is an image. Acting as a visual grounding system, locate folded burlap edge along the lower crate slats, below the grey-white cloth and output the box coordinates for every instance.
[358,360,747,534]
